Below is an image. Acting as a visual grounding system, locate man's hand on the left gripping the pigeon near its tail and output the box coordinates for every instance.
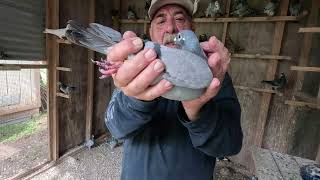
[107,31,173,101]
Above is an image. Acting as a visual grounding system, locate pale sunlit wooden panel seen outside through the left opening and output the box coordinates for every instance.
[0,67,41,119]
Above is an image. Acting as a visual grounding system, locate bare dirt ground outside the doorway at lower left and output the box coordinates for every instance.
[0,118,48,179]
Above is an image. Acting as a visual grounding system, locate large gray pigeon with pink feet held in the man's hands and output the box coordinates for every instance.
[66,21,213,101]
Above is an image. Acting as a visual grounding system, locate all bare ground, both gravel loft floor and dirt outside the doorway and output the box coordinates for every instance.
[0,114,251,180]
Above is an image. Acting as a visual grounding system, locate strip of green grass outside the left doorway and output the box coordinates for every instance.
[0,114,46,143]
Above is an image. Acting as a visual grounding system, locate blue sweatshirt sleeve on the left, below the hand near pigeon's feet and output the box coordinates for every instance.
[105,89,157,139]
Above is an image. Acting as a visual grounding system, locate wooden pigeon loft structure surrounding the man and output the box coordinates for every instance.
[0,0,320,179]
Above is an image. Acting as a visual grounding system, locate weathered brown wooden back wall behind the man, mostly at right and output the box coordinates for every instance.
[115,0,319,169]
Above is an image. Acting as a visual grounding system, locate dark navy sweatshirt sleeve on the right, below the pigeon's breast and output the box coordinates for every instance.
[178,74,243,157]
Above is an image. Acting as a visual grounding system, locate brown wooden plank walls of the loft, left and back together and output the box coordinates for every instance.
[52,0,319,169]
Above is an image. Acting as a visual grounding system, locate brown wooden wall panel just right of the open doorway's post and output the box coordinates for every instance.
[57,0,90,154]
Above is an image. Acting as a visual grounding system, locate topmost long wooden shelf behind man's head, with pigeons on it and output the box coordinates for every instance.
[120,12,308,24]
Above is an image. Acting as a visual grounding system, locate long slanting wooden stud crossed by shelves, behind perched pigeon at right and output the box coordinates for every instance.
[255,0,289,147]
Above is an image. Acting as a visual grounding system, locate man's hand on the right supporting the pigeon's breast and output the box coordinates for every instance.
[182,36,230,121]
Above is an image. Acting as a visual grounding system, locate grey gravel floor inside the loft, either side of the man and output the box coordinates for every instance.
[27,144,251,180]
